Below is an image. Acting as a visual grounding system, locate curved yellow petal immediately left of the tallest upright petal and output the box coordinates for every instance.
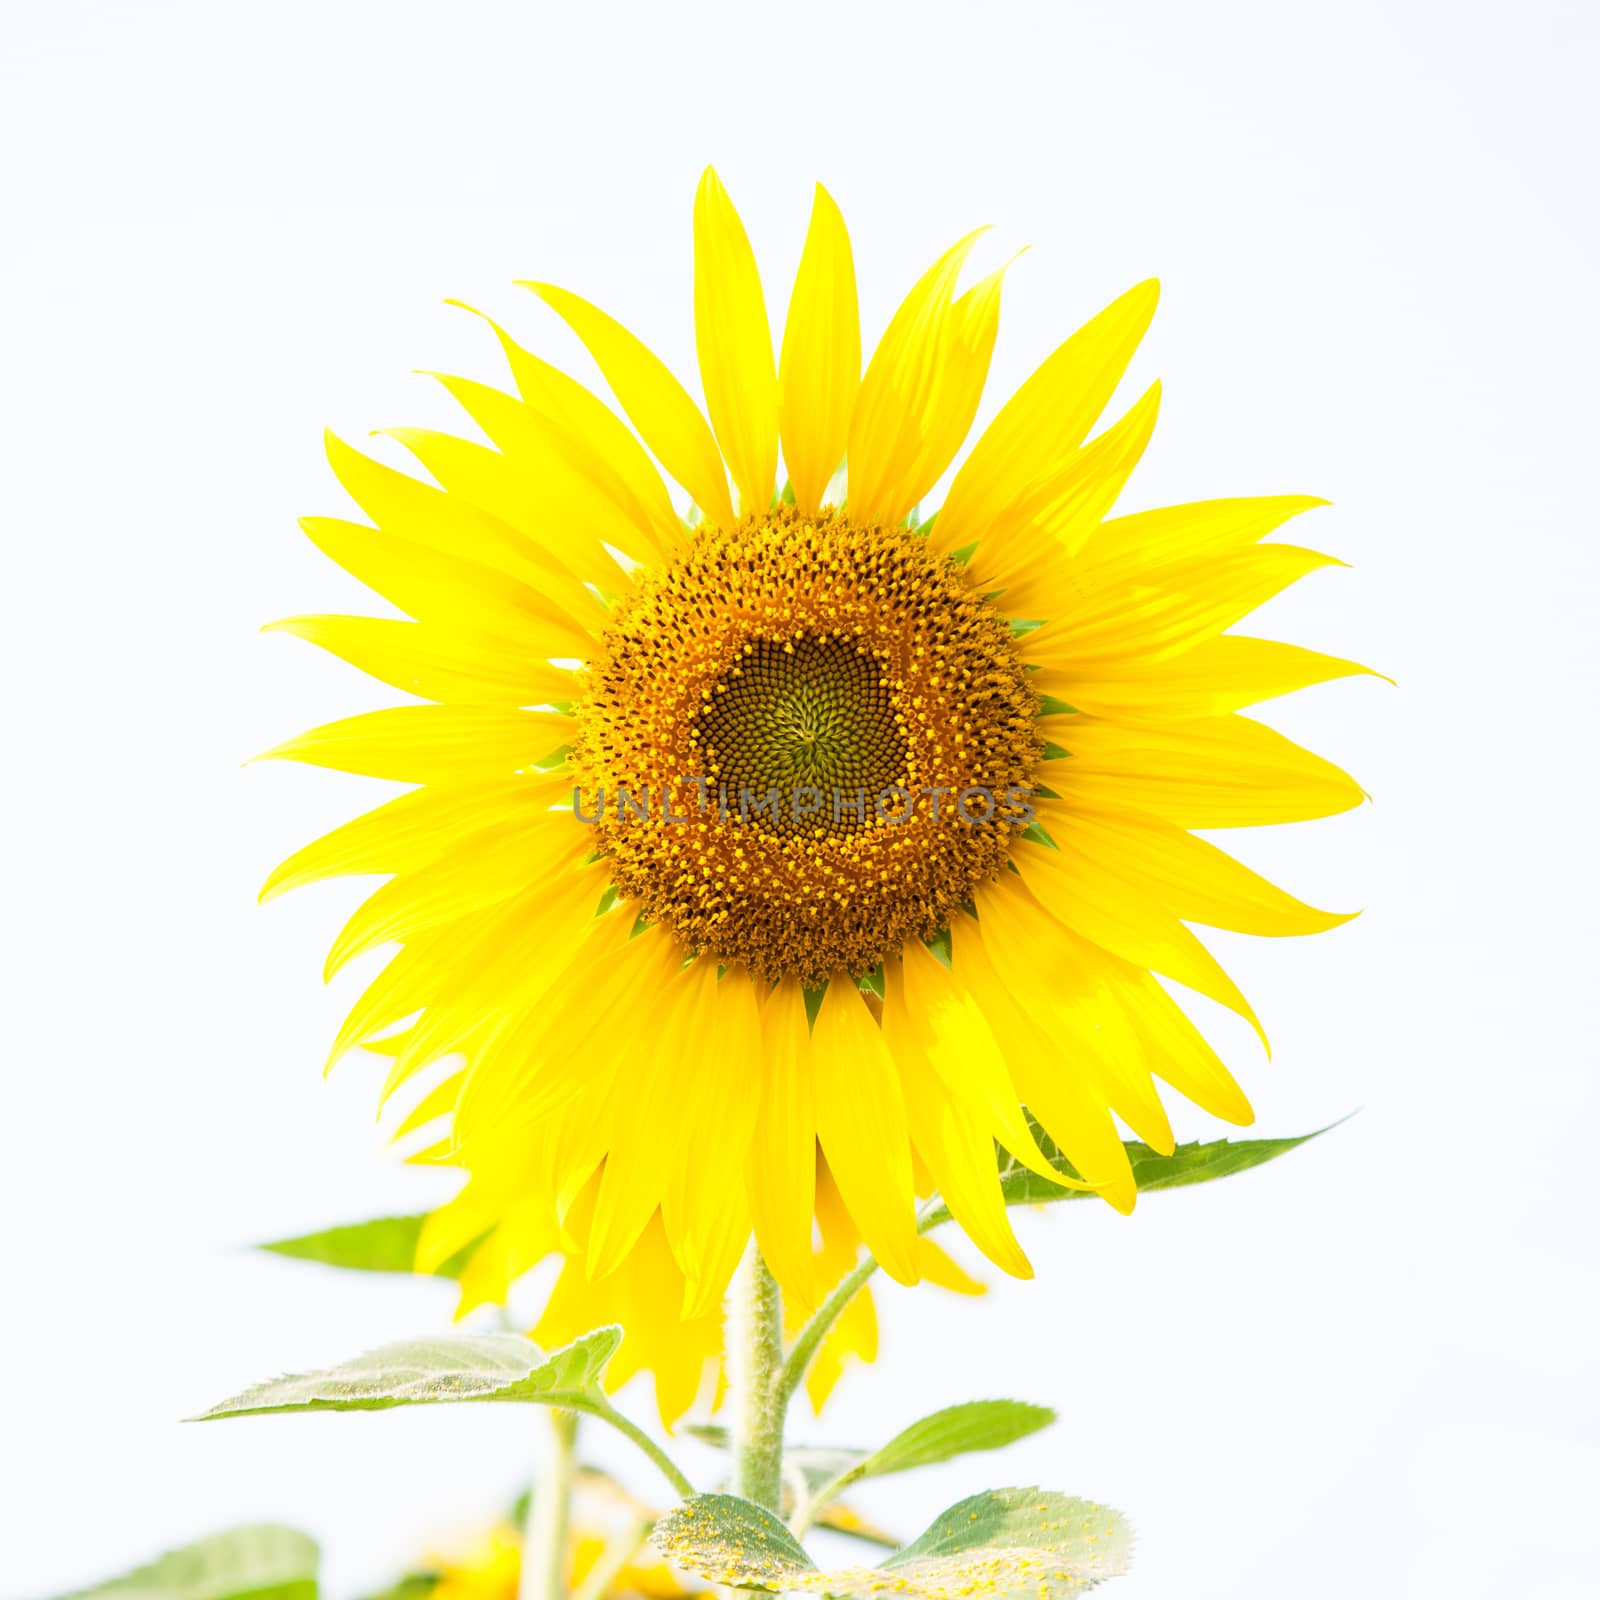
[526,283,733,525]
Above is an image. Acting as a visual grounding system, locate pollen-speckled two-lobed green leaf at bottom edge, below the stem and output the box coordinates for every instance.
[654,1490,1133,1600]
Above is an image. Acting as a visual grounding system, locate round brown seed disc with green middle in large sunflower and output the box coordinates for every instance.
[571,507,1042,982]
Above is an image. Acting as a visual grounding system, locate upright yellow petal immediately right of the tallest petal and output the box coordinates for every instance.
[779,184,861,514]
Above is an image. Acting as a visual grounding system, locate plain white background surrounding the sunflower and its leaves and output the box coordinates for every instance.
[0,0,1600,1600]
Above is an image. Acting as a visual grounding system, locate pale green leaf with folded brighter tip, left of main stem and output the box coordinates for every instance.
[195,1328,622,1422]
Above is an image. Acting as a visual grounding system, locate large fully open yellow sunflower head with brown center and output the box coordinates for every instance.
[267,162,1363,1318]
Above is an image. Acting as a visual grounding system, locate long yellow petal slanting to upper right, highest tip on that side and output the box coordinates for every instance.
[931,278,1160,550]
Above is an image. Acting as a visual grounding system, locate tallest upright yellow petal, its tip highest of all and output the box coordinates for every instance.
[694,166,778,514]
